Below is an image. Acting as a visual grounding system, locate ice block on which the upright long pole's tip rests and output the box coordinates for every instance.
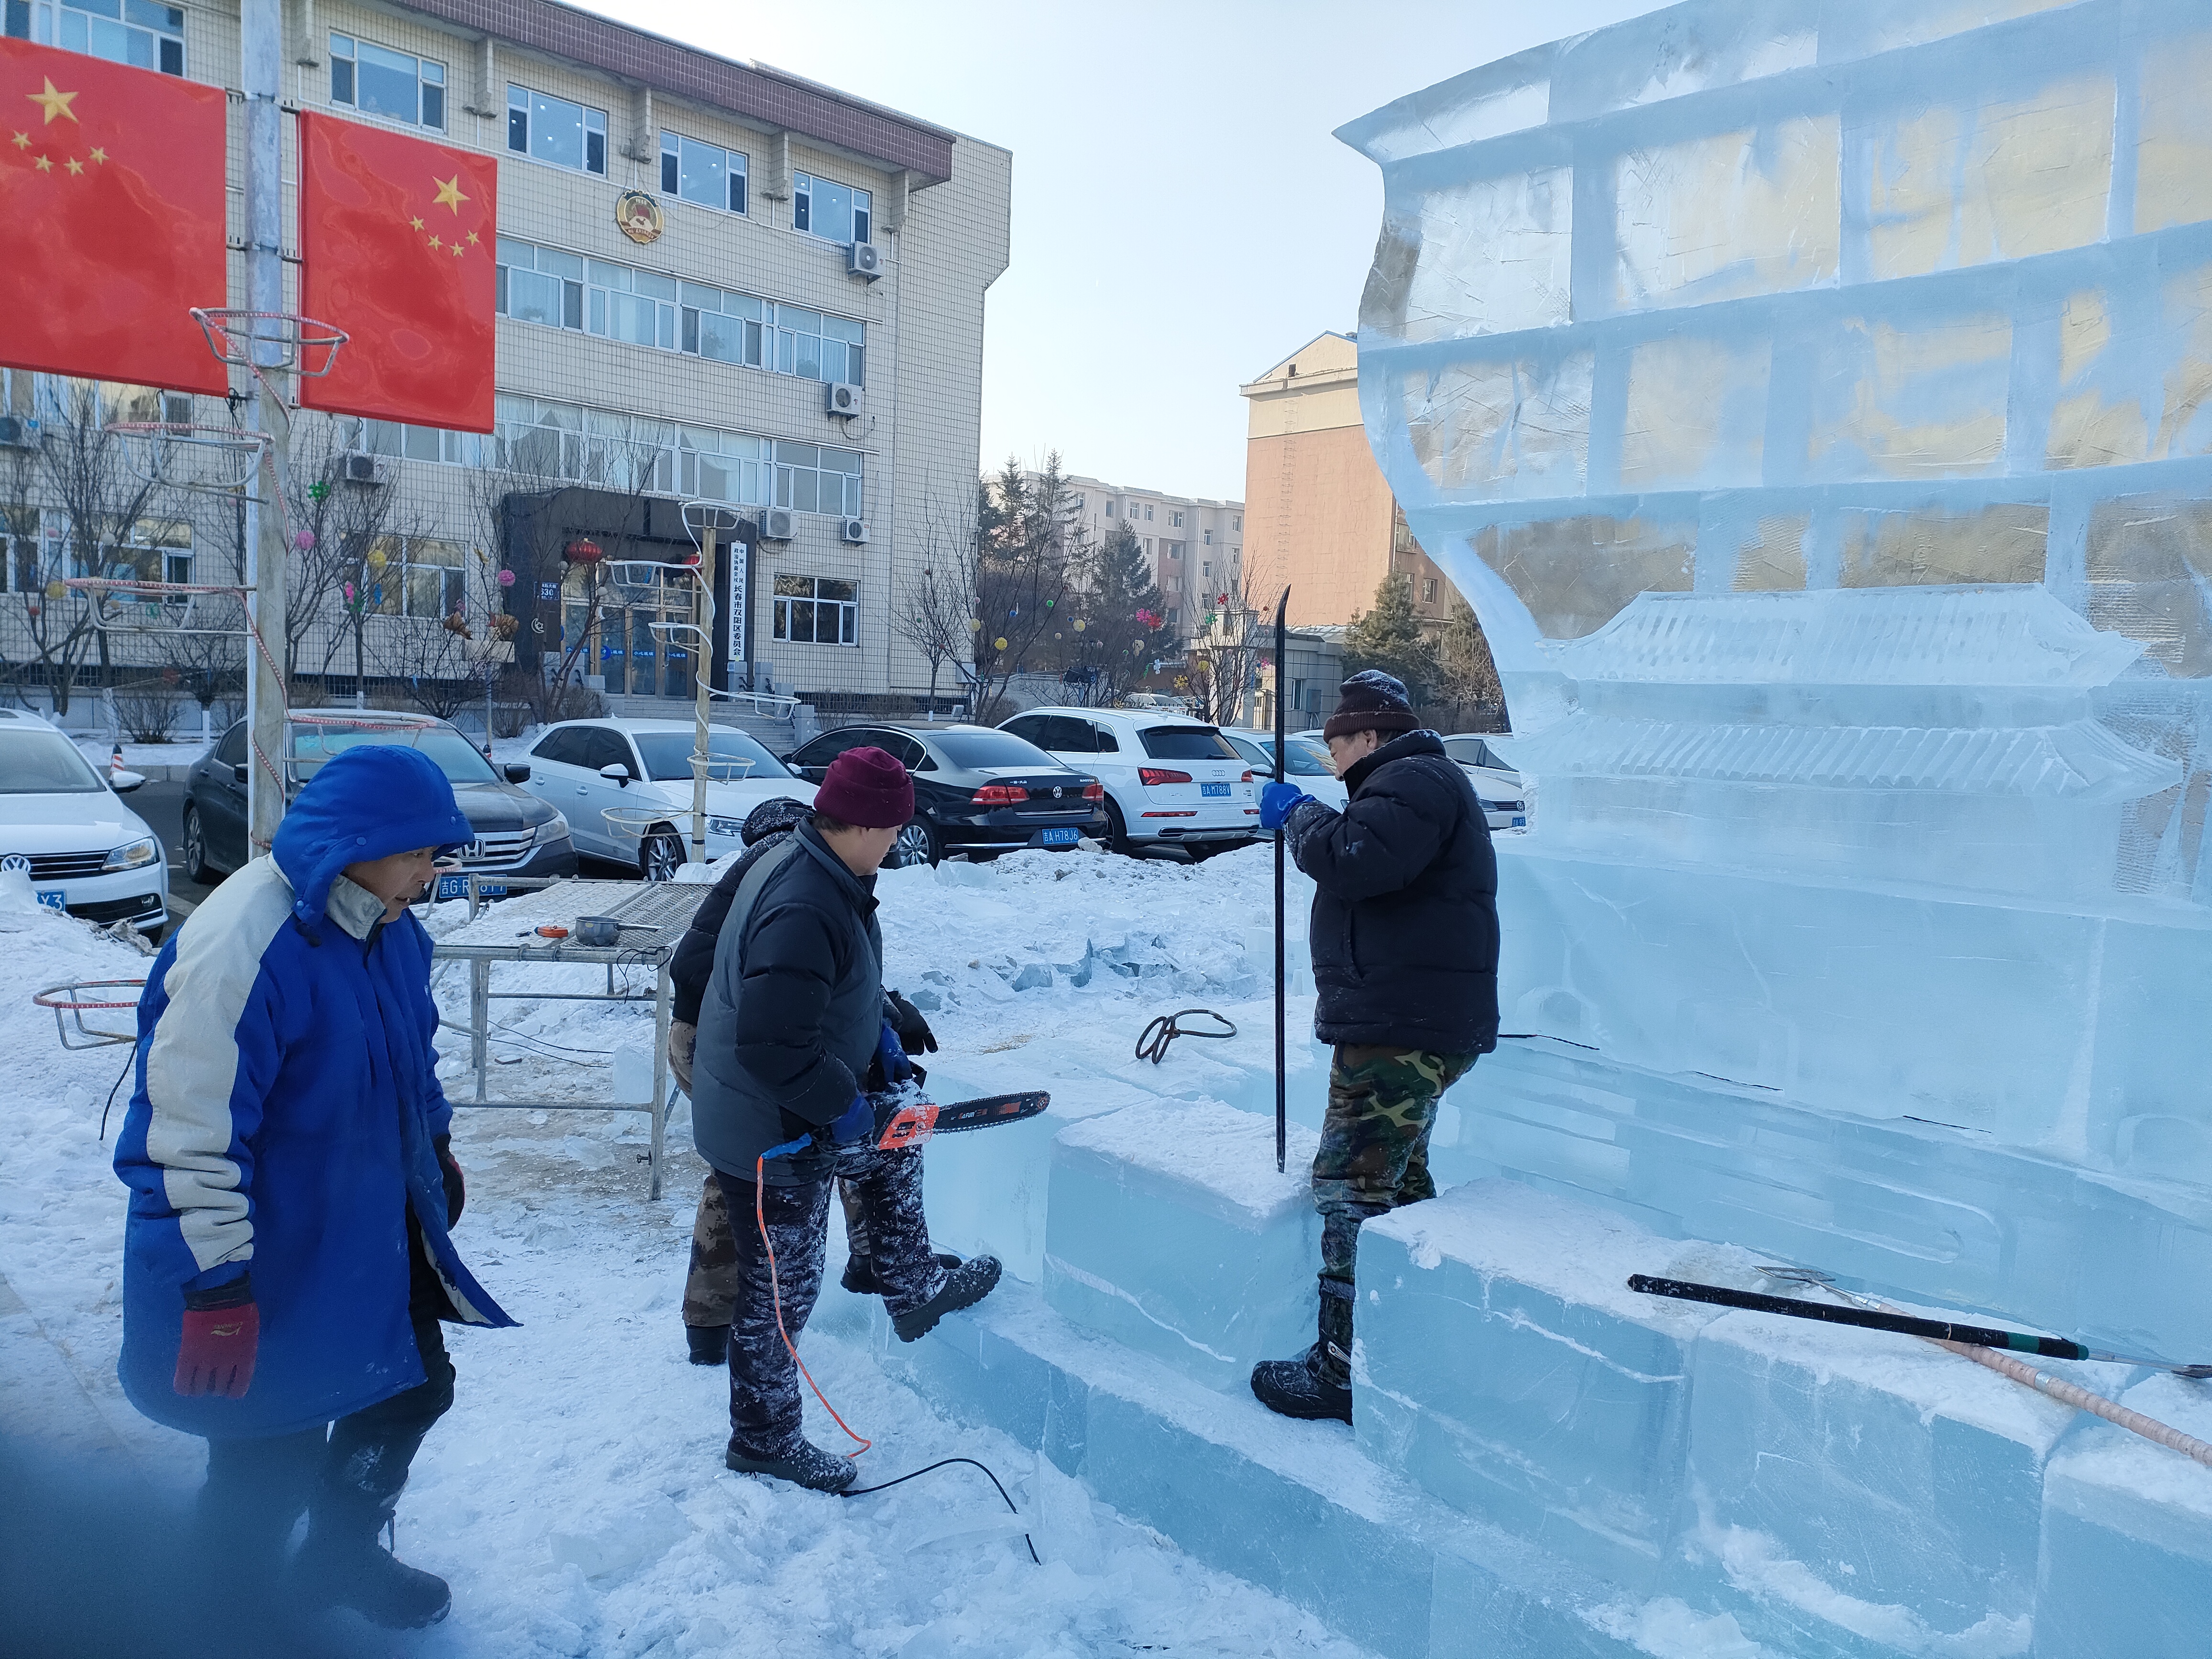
[1044,1102,1321,1391]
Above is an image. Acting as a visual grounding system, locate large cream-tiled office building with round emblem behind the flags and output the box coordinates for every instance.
[0,0,1013,717]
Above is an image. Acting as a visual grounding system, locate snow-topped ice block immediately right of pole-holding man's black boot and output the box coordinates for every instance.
[1354,1181,1756,1593]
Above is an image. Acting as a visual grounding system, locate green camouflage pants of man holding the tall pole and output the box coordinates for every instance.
[1314,1046,1475,1298]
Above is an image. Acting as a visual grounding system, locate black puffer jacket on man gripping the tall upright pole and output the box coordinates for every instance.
[1283,732,1497,1055]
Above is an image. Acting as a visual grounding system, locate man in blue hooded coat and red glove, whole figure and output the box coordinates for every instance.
[115,745,513,1628]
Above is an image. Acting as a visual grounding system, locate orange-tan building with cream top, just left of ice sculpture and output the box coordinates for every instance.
[1237,334,1458,628]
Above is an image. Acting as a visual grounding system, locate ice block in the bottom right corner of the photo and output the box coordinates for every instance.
[2035,1376,2212,1659]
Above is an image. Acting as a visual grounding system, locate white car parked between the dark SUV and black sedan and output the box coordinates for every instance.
[522,719,814,880]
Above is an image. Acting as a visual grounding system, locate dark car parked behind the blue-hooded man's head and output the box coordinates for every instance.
[184,710,575,896]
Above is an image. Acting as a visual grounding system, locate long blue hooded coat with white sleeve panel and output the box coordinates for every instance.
[115,745,513,1438]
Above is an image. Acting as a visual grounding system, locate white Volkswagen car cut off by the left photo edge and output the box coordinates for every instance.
[0,708,168,938]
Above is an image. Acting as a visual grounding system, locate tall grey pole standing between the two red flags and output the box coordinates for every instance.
[239,0,292,854]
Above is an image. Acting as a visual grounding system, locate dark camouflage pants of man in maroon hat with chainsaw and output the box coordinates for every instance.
[715,1146,944,1460]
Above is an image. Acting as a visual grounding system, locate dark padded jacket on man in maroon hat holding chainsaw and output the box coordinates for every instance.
[692,823,883,1183]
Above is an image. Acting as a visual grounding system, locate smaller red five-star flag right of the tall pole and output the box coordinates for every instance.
[299,113,500,431]
